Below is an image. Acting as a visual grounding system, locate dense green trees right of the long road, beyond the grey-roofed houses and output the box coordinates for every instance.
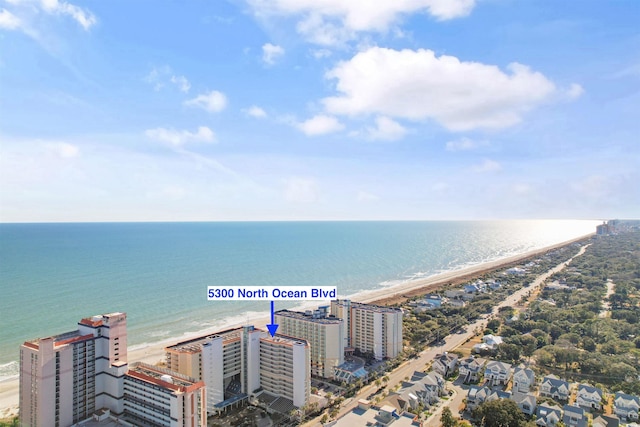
[493,232,640,394]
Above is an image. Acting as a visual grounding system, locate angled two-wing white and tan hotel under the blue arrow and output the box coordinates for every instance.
[165,326,311,413]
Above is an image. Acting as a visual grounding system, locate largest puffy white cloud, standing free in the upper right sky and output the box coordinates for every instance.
[322,47,556,131]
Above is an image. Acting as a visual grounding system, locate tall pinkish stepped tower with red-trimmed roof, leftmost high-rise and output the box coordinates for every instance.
[19,313,127,427]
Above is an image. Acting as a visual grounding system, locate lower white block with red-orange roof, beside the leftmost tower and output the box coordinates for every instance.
[123,363,207,427]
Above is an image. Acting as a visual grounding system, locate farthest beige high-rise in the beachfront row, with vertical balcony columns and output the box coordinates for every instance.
[331,299,402,360]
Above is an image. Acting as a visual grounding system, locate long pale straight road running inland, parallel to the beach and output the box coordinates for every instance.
[304,245,589,427]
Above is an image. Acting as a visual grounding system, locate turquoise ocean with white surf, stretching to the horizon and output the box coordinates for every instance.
[0,220,597,380]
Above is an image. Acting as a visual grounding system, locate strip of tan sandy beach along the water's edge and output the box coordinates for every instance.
[0,232,588,419]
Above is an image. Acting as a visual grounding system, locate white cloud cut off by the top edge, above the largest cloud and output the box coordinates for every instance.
[248,0,476,45]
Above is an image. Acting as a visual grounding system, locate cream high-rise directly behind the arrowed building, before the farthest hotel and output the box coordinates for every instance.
[274,307,345,378]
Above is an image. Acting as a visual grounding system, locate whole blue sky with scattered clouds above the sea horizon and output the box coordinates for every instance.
[0,0,640,222]
